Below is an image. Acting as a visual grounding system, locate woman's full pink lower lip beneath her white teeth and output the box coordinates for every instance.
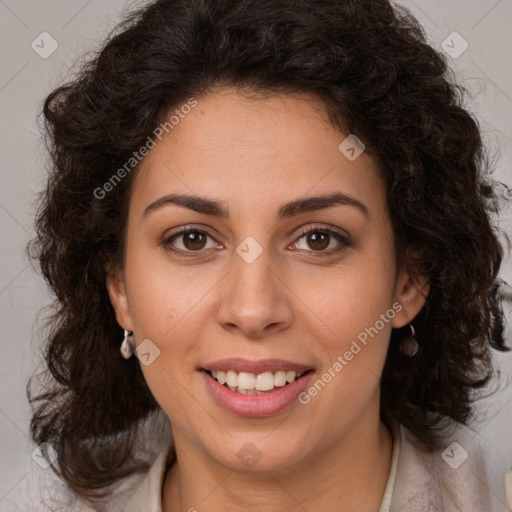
[201,371,313,418]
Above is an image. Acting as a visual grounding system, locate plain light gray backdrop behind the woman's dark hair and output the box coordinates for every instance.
[0,0,512,512]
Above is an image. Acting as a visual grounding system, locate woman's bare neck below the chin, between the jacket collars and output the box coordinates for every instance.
[162,412,393,512]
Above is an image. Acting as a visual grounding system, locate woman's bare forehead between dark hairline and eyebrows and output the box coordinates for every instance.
[132,88,383,218]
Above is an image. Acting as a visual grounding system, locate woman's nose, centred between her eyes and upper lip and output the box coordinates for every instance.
[217,251,293,339]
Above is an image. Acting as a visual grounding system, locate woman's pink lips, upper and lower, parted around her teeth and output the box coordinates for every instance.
[201,358,313,418]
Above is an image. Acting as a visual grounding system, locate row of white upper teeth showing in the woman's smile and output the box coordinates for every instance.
[207,370,304,395]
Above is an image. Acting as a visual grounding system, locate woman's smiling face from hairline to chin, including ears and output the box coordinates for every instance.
[108,88,423,471]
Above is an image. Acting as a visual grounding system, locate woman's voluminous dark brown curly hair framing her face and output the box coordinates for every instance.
[28,0,507,506]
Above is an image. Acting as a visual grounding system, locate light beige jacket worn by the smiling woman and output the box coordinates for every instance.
[123,426,511,512]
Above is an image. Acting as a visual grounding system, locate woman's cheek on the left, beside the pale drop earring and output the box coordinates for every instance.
[125,249,215,425]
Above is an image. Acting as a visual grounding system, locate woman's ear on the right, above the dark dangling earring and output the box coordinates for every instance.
[391,269,430,329]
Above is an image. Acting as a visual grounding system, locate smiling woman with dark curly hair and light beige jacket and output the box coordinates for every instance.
[27,0,506,512]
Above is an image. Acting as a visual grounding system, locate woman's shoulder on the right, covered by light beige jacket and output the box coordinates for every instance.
[390,421,508,512]
